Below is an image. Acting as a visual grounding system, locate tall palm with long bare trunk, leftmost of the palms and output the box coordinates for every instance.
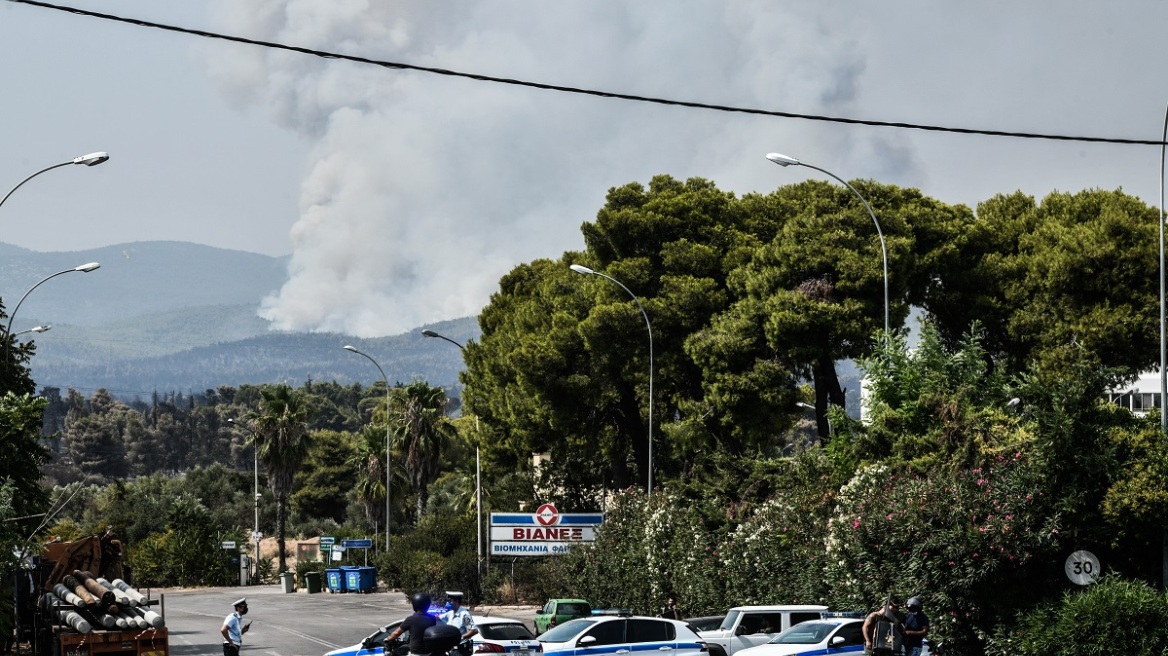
[249,384,308,572]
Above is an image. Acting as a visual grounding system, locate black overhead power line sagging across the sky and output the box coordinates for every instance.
[7,0,1164,146]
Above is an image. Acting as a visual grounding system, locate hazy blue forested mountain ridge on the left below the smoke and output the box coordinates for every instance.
[0,242,478,399]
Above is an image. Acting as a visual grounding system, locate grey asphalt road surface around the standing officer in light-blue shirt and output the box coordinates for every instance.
[156,585,535,656]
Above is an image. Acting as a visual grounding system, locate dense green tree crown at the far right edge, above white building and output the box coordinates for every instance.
[919,189,1159,372]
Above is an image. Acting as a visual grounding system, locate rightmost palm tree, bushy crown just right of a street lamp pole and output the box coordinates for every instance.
[389,381,454,518]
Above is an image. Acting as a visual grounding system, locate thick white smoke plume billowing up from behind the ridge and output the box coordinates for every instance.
[207,0,913,337]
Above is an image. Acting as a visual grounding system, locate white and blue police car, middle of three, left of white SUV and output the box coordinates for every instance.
[538,614,709,656]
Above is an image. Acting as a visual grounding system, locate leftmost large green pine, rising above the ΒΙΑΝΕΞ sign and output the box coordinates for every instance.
[464,176,783,494]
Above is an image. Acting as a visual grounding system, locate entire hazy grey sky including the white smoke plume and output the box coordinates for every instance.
[0,0,1168,336]
